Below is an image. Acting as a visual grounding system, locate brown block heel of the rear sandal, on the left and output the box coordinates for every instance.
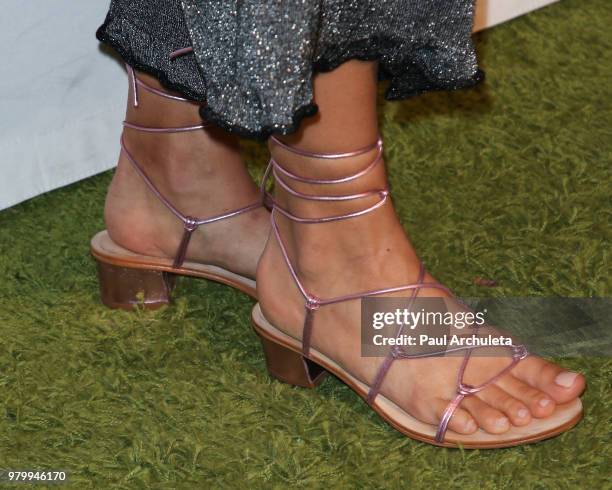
[96,260,176,310]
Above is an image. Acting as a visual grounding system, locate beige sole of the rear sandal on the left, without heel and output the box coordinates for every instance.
[91,230,257,299]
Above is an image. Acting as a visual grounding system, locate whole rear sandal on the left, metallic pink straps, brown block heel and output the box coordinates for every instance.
[91,60,263,309]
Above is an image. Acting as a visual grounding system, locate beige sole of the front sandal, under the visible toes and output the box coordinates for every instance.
[252,303,583,449]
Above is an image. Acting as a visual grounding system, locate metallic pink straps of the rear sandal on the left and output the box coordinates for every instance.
[120,59,263,269]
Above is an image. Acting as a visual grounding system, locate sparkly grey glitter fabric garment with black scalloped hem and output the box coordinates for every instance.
[97,0,482,138]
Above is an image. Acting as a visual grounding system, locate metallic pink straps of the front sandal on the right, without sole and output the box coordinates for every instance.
[262,138,528,443]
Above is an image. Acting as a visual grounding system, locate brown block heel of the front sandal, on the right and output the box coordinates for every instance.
[259,335,327,388]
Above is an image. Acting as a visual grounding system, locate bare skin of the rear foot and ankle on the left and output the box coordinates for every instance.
[104,74,269,278]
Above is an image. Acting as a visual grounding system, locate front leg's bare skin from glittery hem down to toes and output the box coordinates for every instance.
[257,61,584,433]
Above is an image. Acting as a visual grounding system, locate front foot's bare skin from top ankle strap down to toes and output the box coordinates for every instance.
[257,139,585,440]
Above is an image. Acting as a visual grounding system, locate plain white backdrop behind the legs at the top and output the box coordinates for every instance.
[0,0,555,209]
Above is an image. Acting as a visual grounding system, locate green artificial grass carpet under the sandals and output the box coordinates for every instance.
[0,0,612,489]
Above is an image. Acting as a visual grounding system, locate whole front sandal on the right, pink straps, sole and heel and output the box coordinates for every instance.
[252,138,582,449]
